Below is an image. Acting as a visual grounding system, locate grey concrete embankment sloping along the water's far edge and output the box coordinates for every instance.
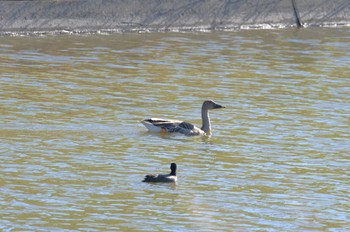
[0,0,350,34]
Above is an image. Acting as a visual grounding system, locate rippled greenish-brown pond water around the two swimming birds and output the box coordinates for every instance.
[0,28,350,231]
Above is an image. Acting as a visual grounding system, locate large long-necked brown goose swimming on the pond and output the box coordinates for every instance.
[141,100,225,136]
